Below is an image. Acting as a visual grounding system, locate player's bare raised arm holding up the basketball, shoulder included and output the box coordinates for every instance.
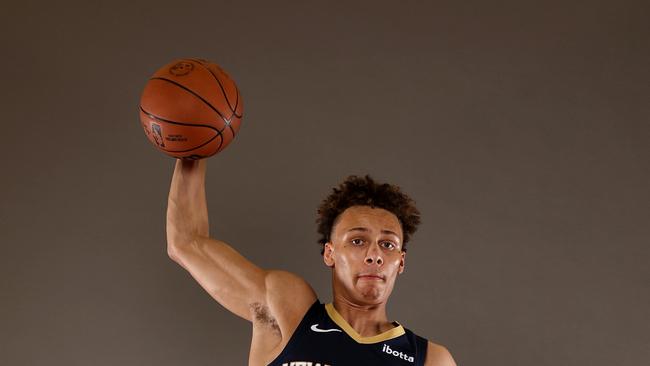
[167,160,316,328]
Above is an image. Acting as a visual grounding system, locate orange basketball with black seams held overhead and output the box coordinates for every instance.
[140,58,242,160]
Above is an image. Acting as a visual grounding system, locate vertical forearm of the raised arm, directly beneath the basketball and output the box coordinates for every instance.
[167,159,209,253]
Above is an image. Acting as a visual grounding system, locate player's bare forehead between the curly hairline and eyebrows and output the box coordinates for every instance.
[334,206,402,238]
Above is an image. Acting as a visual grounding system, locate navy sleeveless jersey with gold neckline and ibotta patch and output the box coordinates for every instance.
[269,300,428,366]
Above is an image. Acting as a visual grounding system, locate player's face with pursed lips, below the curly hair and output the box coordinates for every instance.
[323,206,405,305]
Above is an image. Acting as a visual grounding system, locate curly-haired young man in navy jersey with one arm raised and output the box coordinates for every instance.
[167,160,455,366]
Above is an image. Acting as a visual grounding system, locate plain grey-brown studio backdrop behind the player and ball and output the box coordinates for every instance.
[0,1,650,366]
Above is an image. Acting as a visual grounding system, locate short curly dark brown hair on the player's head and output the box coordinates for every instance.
[316,175,420,255]
